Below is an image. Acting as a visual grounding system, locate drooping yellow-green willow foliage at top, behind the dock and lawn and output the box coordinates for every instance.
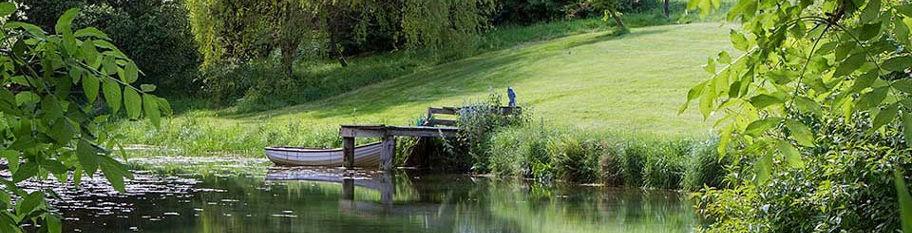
[187,0,494,70]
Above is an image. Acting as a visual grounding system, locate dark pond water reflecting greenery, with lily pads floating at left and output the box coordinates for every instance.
[33,157,695,233]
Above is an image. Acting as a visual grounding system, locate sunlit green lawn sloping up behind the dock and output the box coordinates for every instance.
[124,23,730,155]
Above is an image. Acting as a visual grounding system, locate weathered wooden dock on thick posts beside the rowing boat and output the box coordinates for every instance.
[339,125,459,170]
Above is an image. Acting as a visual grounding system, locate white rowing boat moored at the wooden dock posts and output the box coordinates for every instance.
[266,142,381,167]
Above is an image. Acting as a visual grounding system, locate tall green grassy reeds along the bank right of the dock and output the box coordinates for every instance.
[488,125,727,189]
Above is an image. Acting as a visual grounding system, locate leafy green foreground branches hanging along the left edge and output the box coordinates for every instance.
[0,2,170,232]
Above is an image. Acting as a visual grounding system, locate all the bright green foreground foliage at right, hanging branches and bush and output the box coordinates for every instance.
[685,0,912,232]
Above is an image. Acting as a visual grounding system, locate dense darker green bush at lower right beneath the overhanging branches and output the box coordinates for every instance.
[699,117,912,232]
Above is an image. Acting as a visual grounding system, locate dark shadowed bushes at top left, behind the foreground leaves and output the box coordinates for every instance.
[19,0,200,95]
